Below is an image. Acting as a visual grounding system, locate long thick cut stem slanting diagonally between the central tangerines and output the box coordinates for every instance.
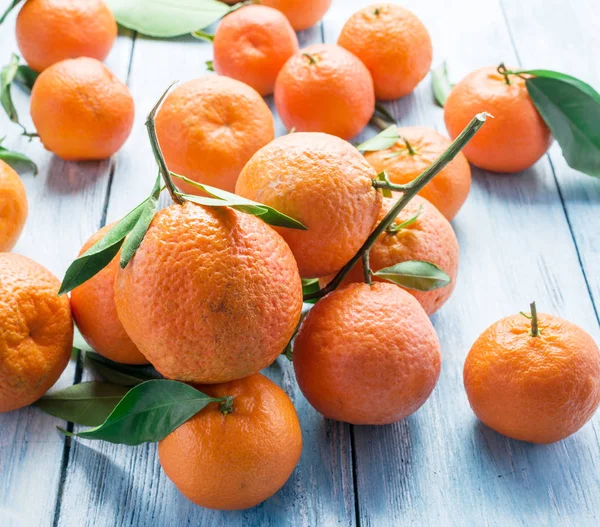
[304,112,489,300]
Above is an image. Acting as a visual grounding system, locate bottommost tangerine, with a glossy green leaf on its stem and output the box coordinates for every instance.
[158,374,302,510]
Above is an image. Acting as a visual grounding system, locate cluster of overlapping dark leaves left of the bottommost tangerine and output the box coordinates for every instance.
[34,350,226,445]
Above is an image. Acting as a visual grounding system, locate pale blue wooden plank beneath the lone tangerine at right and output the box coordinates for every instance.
[324,0,600,526]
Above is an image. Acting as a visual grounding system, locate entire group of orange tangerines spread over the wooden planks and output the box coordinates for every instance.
[0,0,600,509]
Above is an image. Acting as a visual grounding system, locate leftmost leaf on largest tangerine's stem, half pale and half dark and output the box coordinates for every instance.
[58,198,149,295]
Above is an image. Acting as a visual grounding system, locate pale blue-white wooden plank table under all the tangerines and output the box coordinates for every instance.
[0,0,600,527]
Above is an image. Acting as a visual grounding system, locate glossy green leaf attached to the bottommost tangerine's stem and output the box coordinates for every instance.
[59,380,224,445]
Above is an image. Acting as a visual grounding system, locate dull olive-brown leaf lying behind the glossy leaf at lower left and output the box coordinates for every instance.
[33,382,127,426]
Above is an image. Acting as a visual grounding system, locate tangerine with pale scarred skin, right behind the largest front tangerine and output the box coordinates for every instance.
[236,133,381,277]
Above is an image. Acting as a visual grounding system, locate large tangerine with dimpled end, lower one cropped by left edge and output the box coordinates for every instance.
[0,253,73,412]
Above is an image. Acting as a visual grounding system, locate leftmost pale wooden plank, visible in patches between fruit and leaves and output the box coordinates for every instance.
[0,6,131,527]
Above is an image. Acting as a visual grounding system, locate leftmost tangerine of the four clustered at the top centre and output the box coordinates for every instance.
[213,5,298,95]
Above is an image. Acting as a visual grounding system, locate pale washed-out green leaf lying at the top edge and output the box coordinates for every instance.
[107,0,230,38]
